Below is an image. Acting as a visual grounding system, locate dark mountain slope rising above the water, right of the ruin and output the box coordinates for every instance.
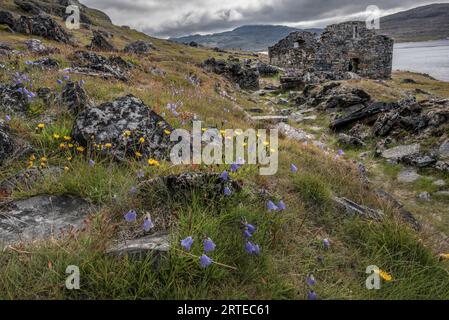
[380,3,449,42]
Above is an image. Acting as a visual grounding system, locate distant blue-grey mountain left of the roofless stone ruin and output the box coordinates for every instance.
[170,25,322,51]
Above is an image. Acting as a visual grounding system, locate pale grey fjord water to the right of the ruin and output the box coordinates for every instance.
[393,40,449,82]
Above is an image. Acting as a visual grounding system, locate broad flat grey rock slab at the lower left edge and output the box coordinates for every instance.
[0,195,93,246]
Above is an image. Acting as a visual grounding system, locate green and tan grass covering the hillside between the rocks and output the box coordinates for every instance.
[0,2,449,299]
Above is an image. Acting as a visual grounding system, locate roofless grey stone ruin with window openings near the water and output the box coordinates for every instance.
[268,21,394,80]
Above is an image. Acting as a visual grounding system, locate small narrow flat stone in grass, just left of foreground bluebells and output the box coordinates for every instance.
[106,234,170,256]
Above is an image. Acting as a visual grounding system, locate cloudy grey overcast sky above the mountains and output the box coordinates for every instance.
[80,0,449,38]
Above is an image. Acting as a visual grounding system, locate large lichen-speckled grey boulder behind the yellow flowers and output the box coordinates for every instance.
[72,95,173,160]
